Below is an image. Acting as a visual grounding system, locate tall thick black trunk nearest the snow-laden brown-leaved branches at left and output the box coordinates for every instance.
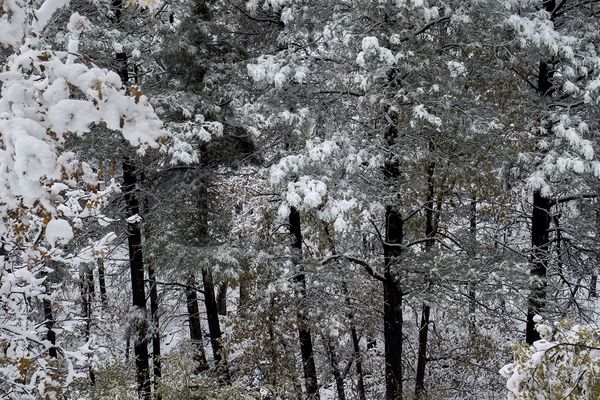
[123,158,151,400]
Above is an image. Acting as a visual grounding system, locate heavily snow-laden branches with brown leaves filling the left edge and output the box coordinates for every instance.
[0,0,165,399]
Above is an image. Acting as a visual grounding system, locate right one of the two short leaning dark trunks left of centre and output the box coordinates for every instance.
[202,269,229,382]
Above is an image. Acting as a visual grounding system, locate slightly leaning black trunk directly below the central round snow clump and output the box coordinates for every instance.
[289,207,320,400]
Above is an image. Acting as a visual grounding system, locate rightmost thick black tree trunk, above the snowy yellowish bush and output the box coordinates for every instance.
[525,190,550,344]
